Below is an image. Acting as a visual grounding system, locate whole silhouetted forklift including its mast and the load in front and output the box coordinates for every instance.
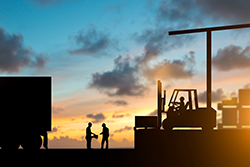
[134,80,216,131]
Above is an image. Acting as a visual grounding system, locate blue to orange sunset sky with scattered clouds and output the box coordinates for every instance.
[0,0,250,148]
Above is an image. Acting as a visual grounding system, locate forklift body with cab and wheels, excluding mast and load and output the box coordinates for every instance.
[163,89,216,130]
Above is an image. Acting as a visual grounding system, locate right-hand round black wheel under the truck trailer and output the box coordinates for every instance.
[21,135,42,150]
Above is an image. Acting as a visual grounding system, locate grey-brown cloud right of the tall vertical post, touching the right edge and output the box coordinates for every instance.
[213,45,250,71]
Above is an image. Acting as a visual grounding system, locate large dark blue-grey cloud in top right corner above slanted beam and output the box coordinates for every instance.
[156,0,250,29]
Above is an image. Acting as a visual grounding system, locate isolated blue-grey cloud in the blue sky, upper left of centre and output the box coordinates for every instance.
[68,25,118,55]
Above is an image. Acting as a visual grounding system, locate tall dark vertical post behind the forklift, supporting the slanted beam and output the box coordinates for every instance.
[207,30,212,108]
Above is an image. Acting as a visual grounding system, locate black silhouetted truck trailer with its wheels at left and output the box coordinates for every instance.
[0,76,52,149]
